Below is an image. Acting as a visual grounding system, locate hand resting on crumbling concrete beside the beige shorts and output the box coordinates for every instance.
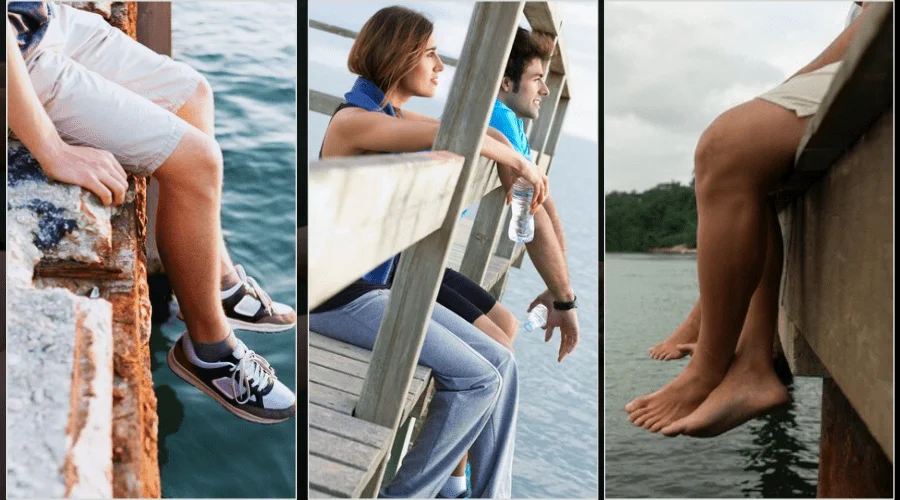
[35,143,128,206]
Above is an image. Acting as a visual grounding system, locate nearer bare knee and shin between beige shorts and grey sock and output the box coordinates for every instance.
[153,127,230,343]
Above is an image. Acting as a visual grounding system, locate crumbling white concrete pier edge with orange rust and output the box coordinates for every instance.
[7,2,160,498]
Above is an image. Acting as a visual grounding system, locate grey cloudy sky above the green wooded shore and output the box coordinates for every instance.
[603,1,851,192]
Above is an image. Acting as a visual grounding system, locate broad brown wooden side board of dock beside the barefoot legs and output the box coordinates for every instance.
[779,113,894,460]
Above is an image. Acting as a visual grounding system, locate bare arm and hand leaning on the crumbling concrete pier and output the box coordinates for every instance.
[6,19,128,205]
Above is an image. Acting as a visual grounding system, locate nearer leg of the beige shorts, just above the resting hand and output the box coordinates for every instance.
[28,51,190,176]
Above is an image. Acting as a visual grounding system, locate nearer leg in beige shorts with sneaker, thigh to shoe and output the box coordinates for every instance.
[26,45,296,422]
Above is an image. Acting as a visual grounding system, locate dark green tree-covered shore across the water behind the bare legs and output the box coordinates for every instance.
[605,182,697,252]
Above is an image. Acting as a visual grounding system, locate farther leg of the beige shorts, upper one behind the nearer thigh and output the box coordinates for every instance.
[47,4,202,112]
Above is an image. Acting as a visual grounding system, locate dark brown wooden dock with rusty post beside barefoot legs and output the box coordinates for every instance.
[776,2,894,498]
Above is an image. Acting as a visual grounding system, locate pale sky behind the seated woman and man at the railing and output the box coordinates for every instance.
[309,1,600,151]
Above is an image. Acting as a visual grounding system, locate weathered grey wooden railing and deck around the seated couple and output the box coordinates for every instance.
[308,2,569,498]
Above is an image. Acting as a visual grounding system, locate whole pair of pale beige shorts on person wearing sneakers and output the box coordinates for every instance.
[25,3,203,177]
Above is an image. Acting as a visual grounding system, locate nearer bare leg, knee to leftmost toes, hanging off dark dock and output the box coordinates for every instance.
[625,99,806,432]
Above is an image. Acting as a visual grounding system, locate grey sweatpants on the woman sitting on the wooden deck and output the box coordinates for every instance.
[309,290,519,498]
